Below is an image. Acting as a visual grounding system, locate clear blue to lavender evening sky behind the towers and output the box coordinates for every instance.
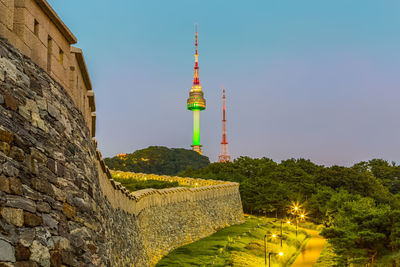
[49,0,400,165]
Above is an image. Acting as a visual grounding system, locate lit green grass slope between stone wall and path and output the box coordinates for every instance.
[156,216,308,267]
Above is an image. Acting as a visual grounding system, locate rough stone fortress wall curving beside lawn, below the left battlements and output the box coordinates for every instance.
[0,38,242,266]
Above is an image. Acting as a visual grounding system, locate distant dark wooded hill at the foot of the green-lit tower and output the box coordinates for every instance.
[104,146,210,175]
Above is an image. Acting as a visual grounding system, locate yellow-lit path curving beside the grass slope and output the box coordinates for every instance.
[292,229,325,267]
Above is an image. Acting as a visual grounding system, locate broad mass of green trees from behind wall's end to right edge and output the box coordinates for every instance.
[179,157,400,266]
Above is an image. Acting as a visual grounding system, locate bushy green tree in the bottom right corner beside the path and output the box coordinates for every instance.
[322,198,398,264]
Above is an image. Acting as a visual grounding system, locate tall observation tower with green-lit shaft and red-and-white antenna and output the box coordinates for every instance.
[187,26,206,154]
